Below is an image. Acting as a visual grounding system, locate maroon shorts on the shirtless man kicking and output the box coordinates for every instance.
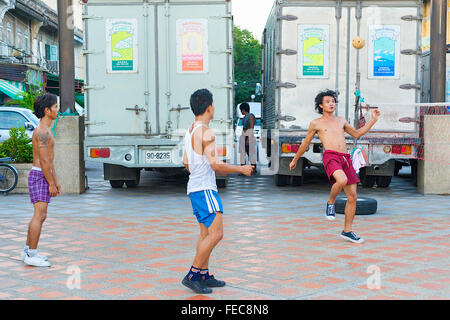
[323,150,359,185]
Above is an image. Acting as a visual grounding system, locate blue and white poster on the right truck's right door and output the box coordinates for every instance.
[369,25,400,79]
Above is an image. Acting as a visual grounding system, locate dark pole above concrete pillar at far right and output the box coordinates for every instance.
[430,0,447,102]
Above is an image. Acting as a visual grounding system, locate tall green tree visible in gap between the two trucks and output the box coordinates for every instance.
[234,26,261,106]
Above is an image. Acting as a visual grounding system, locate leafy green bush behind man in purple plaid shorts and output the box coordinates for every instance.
[0,128,33,163]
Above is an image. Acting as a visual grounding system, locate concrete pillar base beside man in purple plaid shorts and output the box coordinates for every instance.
[52,116,86,194]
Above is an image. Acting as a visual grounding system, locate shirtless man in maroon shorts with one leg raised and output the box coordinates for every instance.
[289,90,380,243]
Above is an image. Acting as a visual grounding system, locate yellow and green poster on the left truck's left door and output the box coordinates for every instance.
[106,19,138,73]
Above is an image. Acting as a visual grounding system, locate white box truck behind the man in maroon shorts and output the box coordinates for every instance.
[262,0,422,187]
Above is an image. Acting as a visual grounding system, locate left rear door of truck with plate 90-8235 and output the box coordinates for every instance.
[85,0,156,137]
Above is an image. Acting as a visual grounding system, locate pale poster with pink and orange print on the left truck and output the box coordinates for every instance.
[177,19,208,73]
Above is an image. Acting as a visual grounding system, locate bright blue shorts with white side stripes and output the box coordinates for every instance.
[189,190,223,228]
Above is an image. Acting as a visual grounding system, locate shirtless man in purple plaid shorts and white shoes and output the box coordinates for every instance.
[21,94,61,267]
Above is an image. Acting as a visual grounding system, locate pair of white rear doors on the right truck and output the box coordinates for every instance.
[277,1,420,132]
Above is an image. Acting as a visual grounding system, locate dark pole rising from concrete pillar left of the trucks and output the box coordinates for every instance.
[58,0,75,112]
